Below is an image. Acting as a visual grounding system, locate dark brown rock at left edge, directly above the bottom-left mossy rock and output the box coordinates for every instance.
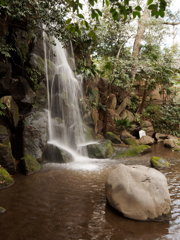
[0,142,16,174]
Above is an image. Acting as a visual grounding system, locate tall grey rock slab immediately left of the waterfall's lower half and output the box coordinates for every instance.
[23,111,48,160]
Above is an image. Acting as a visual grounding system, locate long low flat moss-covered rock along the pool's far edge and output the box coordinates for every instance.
[113,145,151,159]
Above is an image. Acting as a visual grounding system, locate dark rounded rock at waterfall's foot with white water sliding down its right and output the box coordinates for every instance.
[42,144,73,163]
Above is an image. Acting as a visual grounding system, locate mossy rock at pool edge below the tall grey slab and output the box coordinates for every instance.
[20,154,41,175]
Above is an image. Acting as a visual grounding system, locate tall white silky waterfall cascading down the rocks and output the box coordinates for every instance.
[44,37,87,156]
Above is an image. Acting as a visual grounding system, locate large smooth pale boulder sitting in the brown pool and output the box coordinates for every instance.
[105,164,171,220]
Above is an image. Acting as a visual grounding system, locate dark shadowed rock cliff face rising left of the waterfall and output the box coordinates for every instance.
[0,22,49,174]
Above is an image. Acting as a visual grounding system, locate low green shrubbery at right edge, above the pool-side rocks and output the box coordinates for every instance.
[143,104,180,137]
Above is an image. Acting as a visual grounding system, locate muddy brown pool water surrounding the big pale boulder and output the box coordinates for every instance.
[0,144,180,240]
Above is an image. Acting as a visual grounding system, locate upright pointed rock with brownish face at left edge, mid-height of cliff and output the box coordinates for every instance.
[1,96,19,128]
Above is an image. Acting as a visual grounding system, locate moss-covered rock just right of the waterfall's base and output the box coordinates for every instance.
[87,140,114,158]
